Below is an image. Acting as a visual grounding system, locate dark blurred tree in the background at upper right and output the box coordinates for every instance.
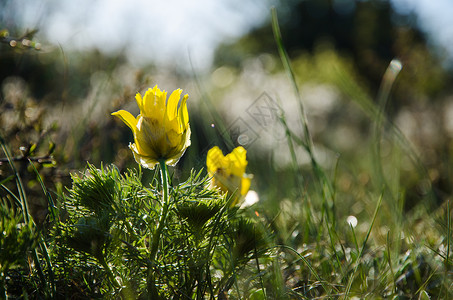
[215,0,451,95]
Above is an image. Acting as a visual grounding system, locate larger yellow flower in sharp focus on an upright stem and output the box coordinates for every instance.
[112,85,190,169]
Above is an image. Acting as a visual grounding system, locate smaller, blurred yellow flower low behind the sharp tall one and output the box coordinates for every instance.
[206,146,250,206]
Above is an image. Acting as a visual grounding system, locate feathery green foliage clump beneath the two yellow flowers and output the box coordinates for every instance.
[38,165,266,299]
